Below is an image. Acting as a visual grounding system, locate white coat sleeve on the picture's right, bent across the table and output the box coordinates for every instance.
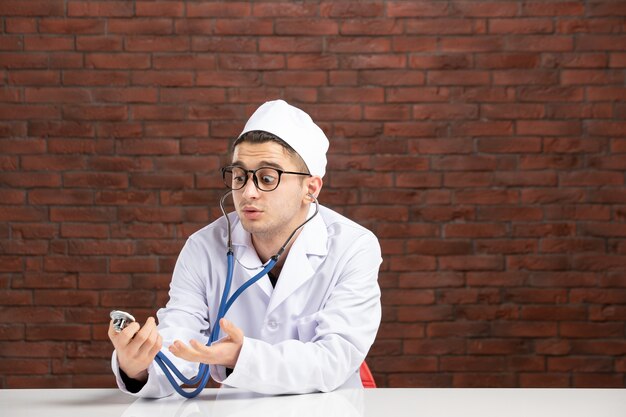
[218,234,382,394]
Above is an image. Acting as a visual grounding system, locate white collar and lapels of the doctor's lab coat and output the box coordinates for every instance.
[232,205,328,313]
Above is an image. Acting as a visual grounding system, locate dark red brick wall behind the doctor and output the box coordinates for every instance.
[0,0,626,388]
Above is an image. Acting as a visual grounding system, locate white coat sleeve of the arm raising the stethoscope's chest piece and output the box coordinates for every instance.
[111,239,209,398]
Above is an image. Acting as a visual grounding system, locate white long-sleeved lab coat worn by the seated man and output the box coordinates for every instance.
[112,206,382,397]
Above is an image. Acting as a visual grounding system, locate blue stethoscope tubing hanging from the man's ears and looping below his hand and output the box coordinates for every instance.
[154,191,319,398]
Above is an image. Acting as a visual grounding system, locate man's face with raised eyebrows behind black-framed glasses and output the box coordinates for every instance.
[232,142,307,238]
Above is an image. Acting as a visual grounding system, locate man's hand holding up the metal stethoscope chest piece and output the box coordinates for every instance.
[109,317,163,382]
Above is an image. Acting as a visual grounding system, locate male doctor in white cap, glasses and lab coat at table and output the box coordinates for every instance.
[108,100,382,397]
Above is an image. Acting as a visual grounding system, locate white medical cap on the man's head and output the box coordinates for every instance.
[239,100,329,177]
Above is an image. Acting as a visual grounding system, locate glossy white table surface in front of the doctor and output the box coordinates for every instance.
[0,388,626,417]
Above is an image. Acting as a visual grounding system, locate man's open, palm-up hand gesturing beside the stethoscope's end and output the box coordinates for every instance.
[170,319,243,368]
